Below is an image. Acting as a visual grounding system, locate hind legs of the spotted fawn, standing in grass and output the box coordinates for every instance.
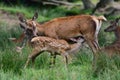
[24,49,41,68]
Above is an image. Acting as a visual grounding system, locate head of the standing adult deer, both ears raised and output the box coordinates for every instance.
[19,12,38,36]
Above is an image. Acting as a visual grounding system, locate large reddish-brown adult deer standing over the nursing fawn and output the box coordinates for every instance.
[16,13,106,67]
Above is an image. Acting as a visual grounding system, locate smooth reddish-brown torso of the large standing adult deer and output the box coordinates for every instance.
[42,15,96,39]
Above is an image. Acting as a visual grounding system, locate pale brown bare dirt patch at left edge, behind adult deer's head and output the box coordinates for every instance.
[0,10,19,28]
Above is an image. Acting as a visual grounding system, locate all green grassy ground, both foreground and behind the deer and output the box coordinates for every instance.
[0,2,120,80]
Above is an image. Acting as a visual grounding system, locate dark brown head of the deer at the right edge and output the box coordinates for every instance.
[104,18,120,32]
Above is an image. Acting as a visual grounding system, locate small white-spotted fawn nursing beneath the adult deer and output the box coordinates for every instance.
[25,36,84,68]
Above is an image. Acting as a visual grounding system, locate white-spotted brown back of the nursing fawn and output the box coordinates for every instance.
[31,37,70,50]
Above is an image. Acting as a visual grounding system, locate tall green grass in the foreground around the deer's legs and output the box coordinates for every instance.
[0,25,120,80]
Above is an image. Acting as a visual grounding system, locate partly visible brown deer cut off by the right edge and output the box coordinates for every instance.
[102,18,120,57]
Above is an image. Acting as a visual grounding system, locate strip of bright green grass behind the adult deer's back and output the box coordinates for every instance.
[0,3,80,21]
